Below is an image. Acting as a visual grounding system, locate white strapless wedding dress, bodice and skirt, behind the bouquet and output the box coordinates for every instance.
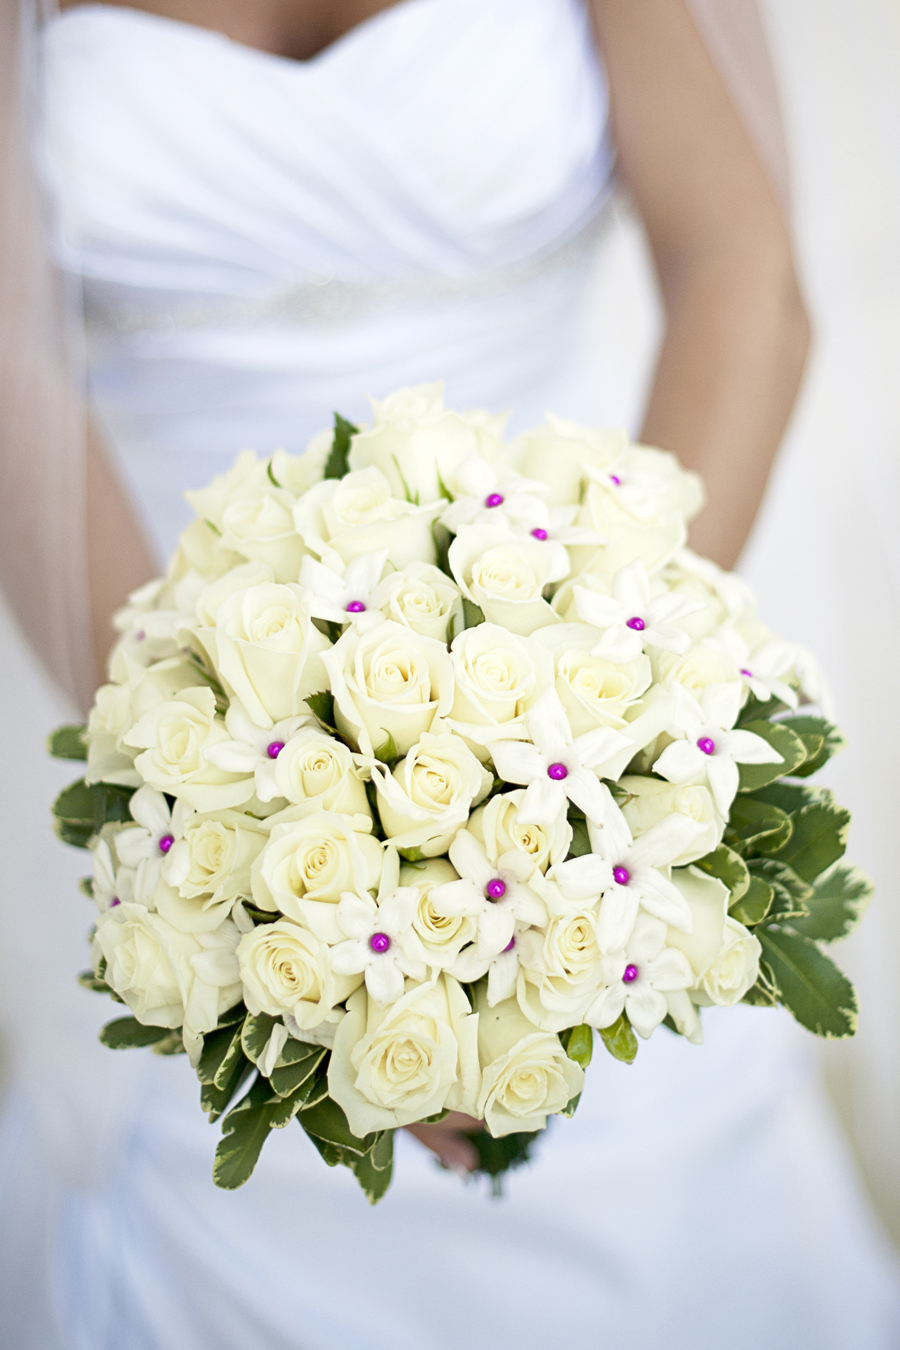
[0,0,900,1350]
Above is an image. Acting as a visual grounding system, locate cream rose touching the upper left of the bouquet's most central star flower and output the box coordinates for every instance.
[447,624,553,759]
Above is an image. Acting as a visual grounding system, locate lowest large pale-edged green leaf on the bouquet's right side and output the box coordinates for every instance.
[758,927,857,1040]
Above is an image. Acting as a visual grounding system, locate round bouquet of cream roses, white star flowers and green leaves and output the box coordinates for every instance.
[51,385,870,1200]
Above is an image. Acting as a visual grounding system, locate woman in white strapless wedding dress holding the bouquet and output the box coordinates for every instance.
[0,0,900,1350]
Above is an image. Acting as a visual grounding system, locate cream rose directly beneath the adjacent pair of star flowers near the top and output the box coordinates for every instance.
[449,525,559,636]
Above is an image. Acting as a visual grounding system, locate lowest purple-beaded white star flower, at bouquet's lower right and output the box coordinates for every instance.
[584,914,694,1038]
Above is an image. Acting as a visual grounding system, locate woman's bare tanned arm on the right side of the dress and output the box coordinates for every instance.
[592,0,810,567]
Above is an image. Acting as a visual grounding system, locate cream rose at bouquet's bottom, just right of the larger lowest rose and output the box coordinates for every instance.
[476,987,584,1139]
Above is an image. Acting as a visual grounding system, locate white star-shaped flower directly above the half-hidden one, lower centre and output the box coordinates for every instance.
[430,829,546,977]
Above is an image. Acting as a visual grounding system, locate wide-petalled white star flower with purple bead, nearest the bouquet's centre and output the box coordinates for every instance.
[488,689,631,828]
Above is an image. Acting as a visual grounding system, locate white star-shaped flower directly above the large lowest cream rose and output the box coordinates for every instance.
[331,846,428,1007]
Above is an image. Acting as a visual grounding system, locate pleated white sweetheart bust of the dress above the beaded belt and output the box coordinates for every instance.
[35,0,611,288]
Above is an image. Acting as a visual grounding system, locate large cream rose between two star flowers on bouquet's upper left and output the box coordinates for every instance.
[198,583,331,726]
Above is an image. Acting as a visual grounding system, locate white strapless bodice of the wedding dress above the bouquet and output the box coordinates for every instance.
[40,0,613,553]
